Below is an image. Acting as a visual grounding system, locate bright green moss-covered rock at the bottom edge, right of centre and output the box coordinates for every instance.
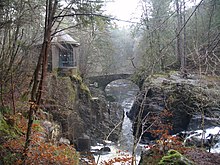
[158,150,194,165]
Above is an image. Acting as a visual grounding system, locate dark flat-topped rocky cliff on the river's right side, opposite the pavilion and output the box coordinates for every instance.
[127,72,220,140]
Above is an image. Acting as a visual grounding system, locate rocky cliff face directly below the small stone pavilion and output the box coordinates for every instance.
[44,75,123,144]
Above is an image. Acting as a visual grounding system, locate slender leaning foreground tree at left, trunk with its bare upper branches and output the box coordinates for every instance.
[22,0,110,164]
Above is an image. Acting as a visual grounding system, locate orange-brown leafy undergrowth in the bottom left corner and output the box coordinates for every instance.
[0,114,79,165]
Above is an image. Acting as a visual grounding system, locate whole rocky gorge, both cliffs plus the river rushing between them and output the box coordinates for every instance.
[0,71,220,164]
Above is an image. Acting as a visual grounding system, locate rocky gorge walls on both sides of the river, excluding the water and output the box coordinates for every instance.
[44,72,220,160]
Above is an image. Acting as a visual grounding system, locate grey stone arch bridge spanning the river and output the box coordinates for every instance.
[87,74,132,90]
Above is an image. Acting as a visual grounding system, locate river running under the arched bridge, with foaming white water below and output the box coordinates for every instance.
[92,80,220,165]
